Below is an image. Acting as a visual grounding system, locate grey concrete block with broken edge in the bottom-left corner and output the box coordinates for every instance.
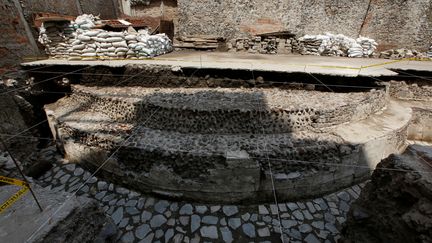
[0,184,116,242]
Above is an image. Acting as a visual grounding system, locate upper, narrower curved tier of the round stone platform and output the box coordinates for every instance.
[62,85,387,134]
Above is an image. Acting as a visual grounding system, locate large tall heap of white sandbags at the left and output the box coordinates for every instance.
[39,15,172,60]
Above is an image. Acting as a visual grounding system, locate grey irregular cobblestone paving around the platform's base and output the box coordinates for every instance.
[5,145,363,242]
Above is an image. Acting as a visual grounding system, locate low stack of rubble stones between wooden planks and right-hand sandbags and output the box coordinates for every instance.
[228,36,298,54]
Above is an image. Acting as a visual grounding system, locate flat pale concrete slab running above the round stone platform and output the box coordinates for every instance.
[22,51,432,77]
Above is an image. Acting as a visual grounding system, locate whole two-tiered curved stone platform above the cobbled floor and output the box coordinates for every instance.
[45,85,411,203]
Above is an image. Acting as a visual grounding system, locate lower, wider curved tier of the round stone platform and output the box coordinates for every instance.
[46,94,411,202]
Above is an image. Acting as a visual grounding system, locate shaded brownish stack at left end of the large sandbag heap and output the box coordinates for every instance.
[39,22,75,58]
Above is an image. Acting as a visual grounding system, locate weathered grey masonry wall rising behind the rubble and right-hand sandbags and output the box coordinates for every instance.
[178,0,432,50]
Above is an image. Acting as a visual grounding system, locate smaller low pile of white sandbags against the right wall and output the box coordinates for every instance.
[299,33,378,57]
